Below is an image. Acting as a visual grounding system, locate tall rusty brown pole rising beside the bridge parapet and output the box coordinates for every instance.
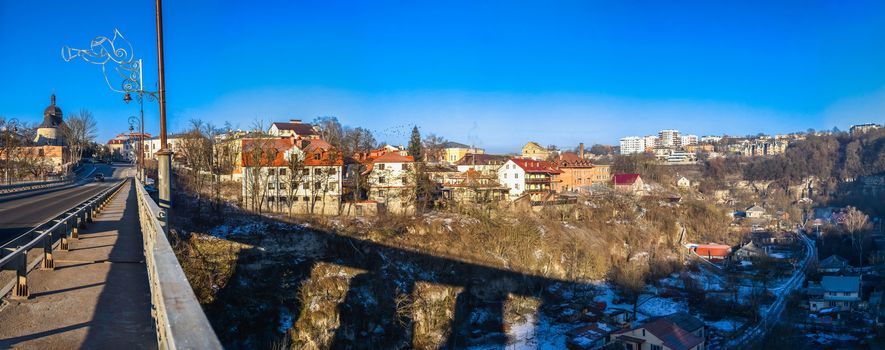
[157,0,172,224]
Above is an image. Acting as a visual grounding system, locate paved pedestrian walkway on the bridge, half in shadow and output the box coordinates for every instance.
[0,180,157,349]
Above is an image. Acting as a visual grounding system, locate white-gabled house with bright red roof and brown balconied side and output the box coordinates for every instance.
[498,158,562,200]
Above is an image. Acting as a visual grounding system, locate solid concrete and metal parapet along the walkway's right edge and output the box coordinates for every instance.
[135,180,222,349]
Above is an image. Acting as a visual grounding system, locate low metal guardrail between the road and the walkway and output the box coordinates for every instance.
[0,181,125,299]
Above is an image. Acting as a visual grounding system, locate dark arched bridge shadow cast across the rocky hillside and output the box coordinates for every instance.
[193,214,592,349]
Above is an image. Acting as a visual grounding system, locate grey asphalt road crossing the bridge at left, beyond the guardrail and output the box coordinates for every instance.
[0,164,129,244]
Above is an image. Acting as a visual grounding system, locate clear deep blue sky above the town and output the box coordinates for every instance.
[0,0,885,151]
